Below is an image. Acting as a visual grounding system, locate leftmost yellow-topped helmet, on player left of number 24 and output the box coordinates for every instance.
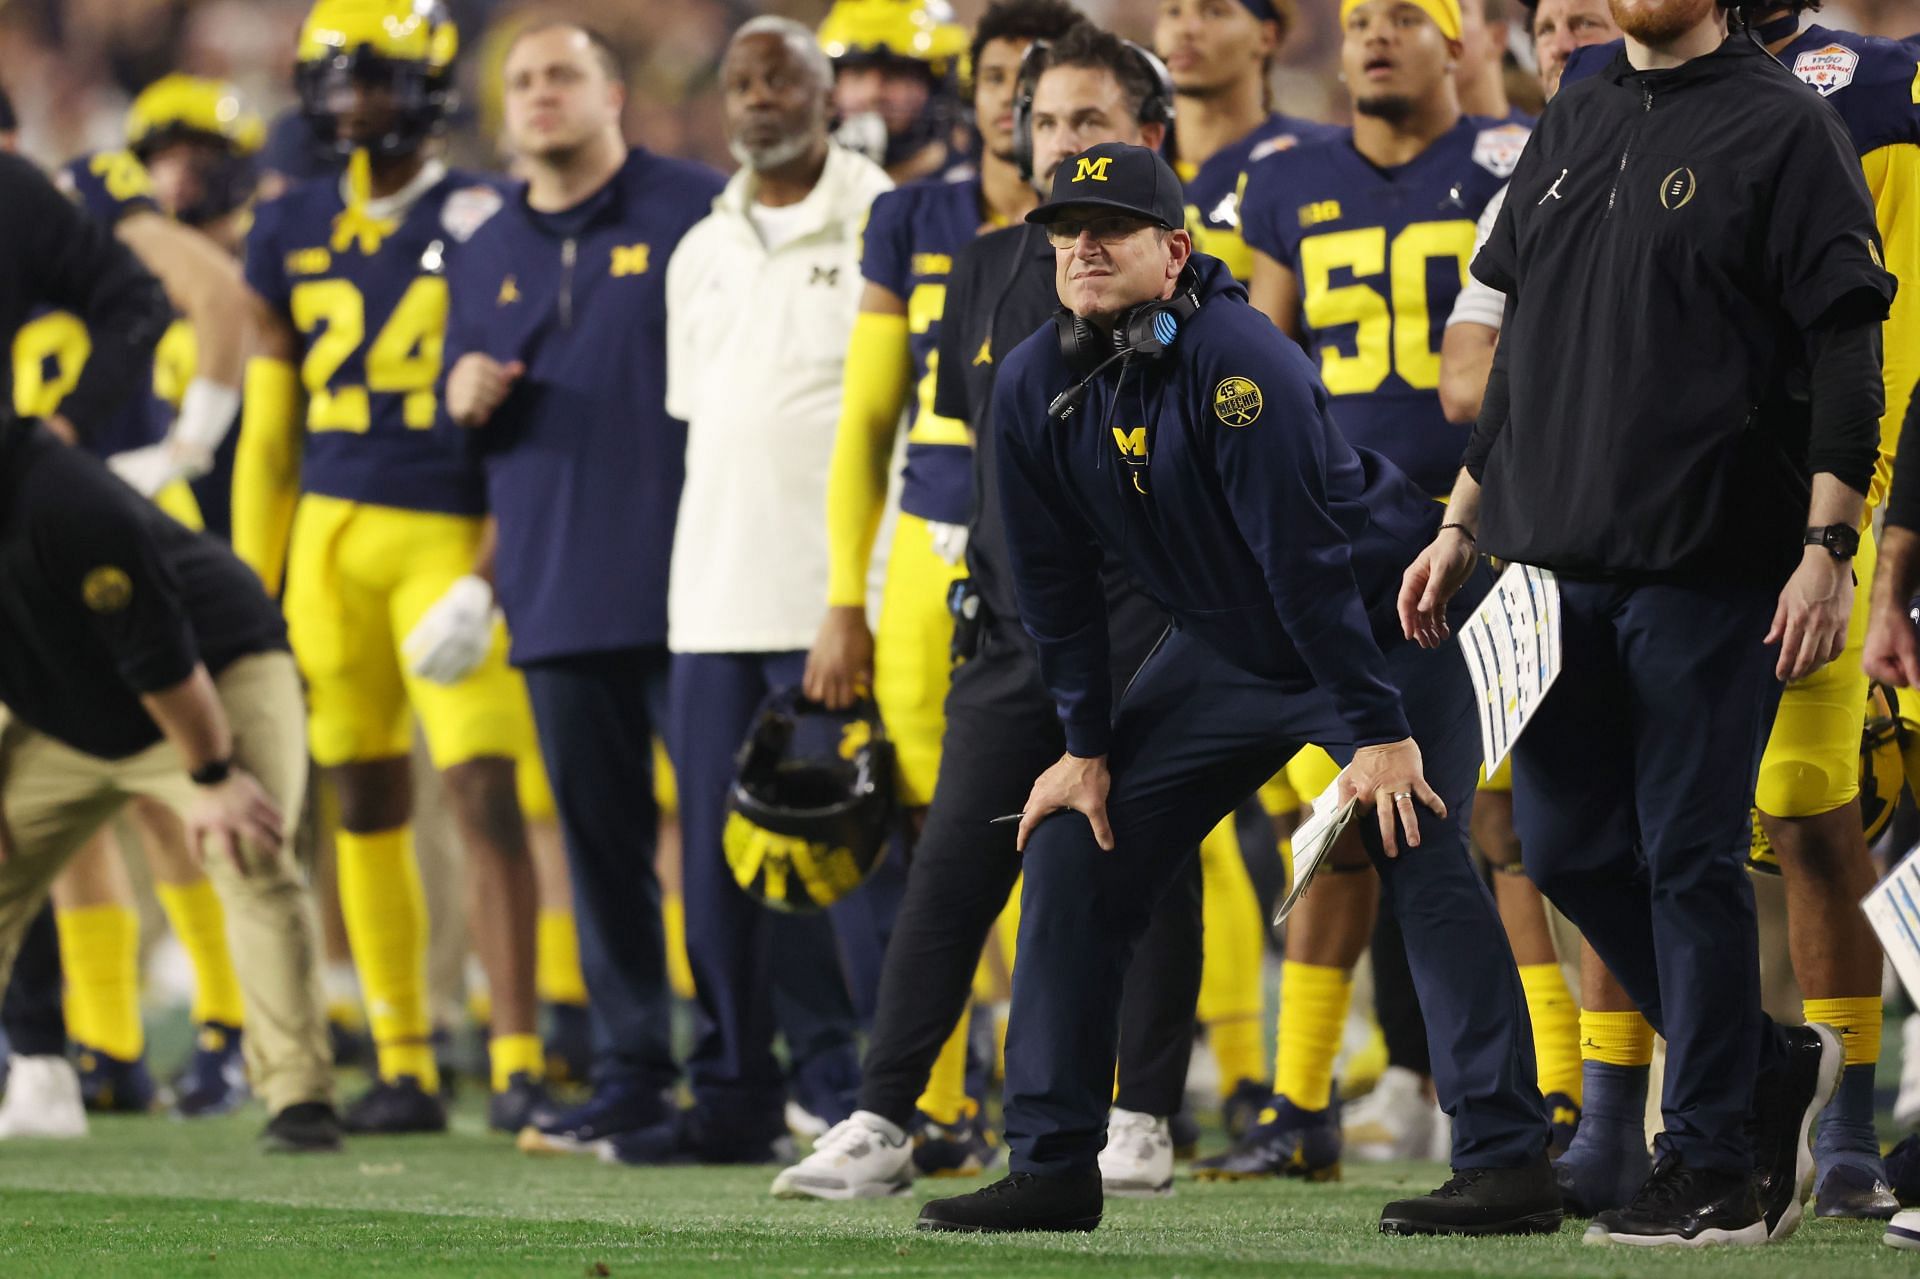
[127,75,267,227]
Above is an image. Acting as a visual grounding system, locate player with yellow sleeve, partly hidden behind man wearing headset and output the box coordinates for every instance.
[804,0,1079,1173]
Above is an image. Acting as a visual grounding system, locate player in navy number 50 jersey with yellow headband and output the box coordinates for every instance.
[1194,0,1526,1179]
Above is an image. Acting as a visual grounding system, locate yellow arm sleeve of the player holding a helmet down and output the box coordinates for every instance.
[828,311,914,609]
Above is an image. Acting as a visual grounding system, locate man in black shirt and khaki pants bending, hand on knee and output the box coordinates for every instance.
[0,422,340,1150]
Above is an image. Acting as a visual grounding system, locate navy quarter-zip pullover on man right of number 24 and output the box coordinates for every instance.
[442,148,724,664]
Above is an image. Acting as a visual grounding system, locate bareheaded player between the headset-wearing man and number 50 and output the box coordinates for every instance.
[1154,0,1338,282]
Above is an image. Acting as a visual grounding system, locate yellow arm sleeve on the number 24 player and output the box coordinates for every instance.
[232,357,300,595]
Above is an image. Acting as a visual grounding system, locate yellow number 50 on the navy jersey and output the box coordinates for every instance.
[1300,221,1473,396]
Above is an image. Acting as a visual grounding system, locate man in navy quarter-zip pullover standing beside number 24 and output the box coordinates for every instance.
[445,21,722,1150]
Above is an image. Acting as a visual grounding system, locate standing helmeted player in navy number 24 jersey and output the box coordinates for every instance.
[234,0,551,1133]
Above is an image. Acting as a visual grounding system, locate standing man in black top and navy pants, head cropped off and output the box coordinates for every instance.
[1400,0,1893,1244]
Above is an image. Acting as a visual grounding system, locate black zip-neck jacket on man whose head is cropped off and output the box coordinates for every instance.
[1465,35,1893,580]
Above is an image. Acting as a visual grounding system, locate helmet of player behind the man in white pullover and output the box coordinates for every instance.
[818,0,970,167]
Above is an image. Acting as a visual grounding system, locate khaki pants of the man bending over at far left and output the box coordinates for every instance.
[0,653,332,1114]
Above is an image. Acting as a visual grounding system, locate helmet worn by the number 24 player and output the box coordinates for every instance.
[294,0,459,156]
